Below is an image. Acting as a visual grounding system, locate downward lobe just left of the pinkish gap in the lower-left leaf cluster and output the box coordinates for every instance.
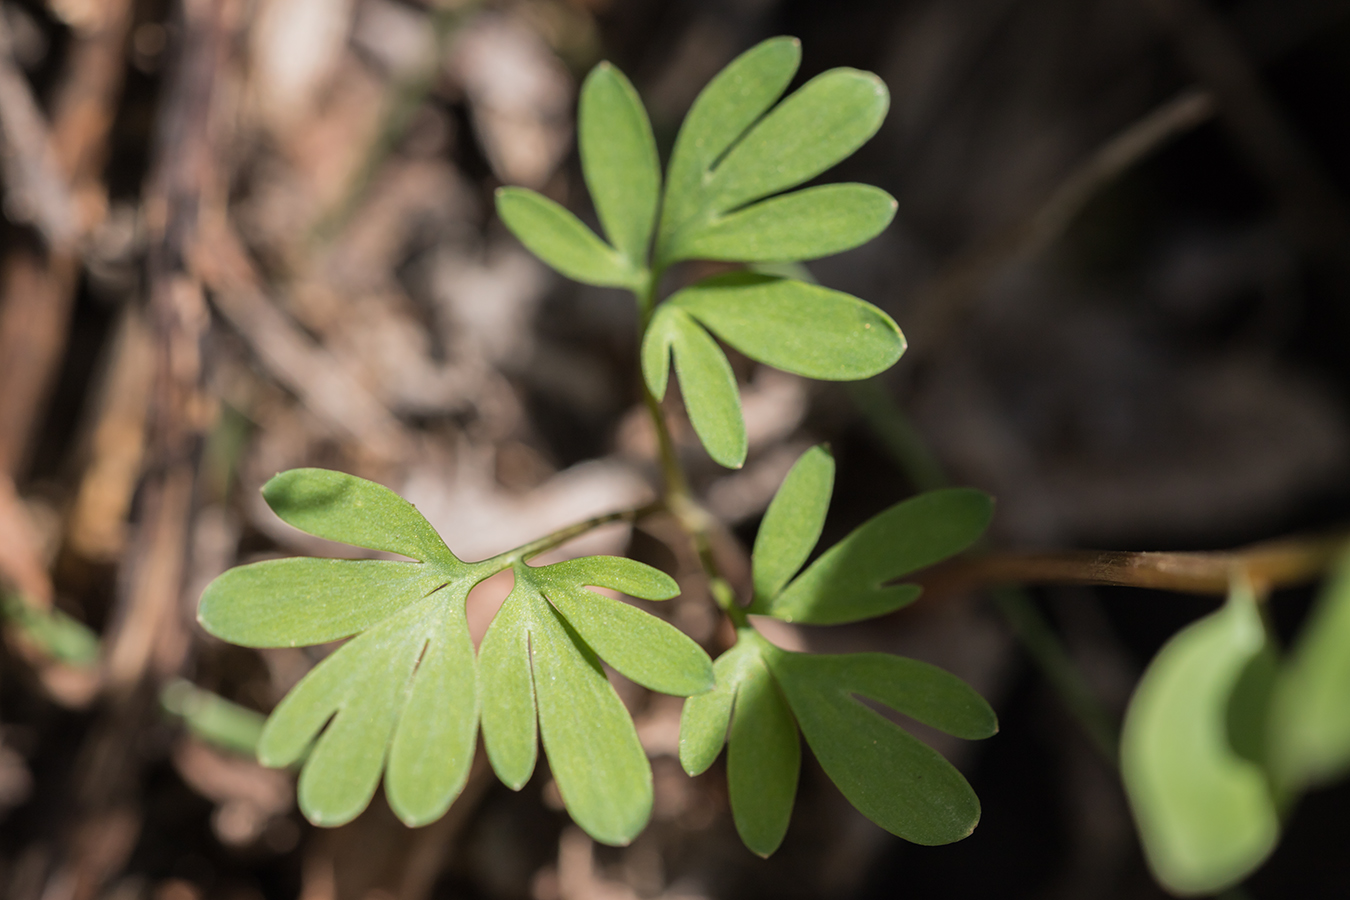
[385,587,478,827]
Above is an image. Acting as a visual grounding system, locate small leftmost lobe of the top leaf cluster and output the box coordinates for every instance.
[497,188,643,289]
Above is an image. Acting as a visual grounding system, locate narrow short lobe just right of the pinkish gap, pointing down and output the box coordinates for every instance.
[478,578,539,791]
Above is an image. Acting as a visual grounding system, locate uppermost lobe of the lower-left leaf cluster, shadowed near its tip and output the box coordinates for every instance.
[262,468,459,564]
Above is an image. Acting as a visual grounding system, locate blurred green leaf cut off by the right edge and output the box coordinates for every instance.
[1270,553,1350,789]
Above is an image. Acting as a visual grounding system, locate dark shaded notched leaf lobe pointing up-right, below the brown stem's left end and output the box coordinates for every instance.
[751,488,994,625]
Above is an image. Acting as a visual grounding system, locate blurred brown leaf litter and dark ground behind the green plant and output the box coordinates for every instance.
[0,0,1350,900]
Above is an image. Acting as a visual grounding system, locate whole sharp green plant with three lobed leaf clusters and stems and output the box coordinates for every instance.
[200,38,996,855]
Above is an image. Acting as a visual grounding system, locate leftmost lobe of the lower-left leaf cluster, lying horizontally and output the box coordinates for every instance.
[197,557,443,646]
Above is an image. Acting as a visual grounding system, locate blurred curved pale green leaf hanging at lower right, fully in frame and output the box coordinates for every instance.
[1121,587,1280,895]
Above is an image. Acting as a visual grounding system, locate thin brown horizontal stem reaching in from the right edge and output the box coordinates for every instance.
[919,533,1350,595]
